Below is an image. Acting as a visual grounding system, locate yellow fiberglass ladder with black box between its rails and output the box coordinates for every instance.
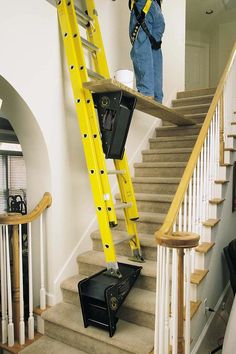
[56,0,143,278]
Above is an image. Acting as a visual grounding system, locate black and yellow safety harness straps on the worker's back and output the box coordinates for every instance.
[130,0,162,50]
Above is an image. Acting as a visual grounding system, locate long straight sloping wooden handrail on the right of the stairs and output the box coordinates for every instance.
[155,42,236,239]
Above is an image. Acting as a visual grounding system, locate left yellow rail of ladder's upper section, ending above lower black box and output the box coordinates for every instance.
[62,1,117,226]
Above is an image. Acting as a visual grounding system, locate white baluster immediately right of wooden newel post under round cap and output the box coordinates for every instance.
[185,250,191,354]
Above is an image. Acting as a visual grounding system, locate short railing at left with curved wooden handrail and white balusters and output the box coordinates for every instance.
[0,193,52,347]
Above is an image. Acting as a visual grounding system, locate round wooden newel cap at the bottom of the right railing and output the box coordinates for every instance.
[156,231,200,248]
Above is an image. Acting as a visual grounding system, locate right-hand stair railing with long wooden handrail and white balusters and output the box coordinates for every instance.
[154,43,236,354]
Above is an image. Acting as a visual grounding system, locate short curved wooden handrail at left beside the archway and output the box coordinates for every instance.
[0,192,52,225]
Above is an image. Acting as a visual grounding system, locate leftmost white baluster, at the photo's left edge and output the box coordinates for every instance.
[0,225,7,344]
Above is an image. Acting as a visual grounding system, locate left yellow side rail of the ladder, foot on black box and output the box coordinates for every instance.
[57,1,118,269]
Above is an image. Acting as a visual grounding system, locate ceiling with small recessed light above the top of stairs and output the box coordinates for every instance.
[186,0,236,30]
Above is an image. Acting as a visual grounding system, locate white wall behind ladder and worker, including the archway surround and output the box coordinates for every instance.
[0,0,185,303]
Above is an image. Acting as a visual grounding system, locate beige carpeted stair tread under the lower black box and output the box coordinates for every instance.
[43,303,154,354]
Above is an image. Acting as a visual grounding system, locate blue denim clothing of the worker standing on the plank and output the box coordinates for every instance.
[129,0,165,102]
